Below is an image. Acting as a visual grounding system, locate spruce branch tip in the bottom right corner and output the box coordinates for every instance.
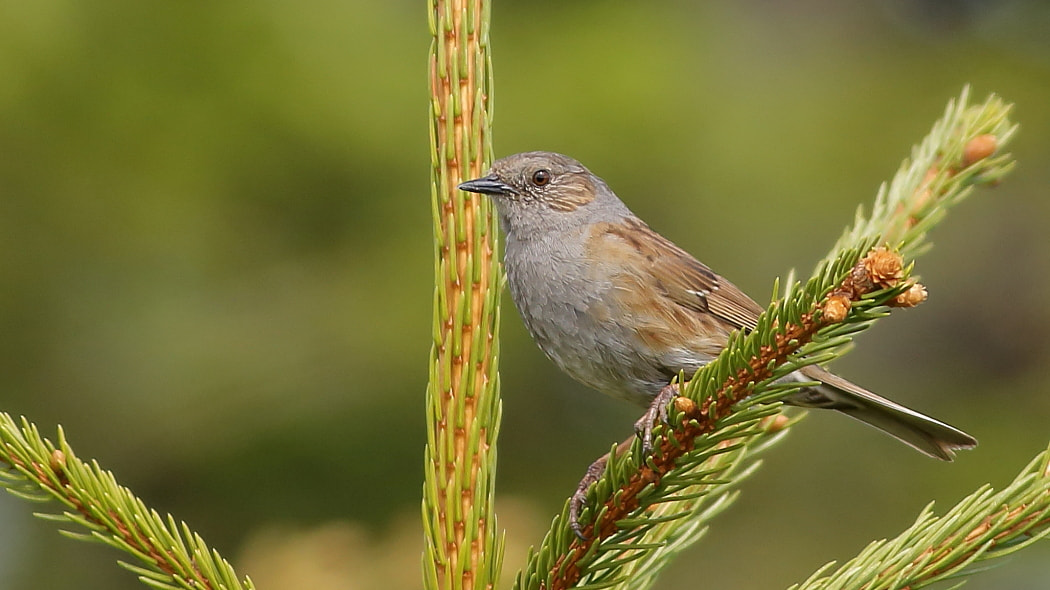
[790,440,1050,590]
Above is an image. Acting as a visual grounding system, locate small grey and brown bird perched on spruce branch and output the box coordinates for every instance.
[459,151,978,534]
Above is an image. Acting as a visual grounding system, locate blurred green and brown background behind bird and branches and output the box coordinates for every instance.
[0,0,1050,590]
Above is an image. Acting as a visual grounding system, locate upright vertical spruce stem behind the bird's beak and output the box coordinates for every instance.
[422,0,502,590]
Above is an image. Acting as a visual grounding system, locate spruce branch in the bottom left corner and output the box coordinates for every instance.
[0,413,254,590]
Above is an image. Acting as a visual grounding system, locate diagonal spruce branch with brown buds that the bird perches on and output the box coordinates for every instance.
[517,89,1016,589]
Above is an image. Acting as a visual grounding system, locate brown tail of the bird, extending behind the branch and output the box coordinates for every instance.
[785,365,978,461]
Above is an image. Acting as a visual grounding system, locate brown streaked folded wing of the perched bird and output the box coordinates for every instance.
[610,218,764,330]
